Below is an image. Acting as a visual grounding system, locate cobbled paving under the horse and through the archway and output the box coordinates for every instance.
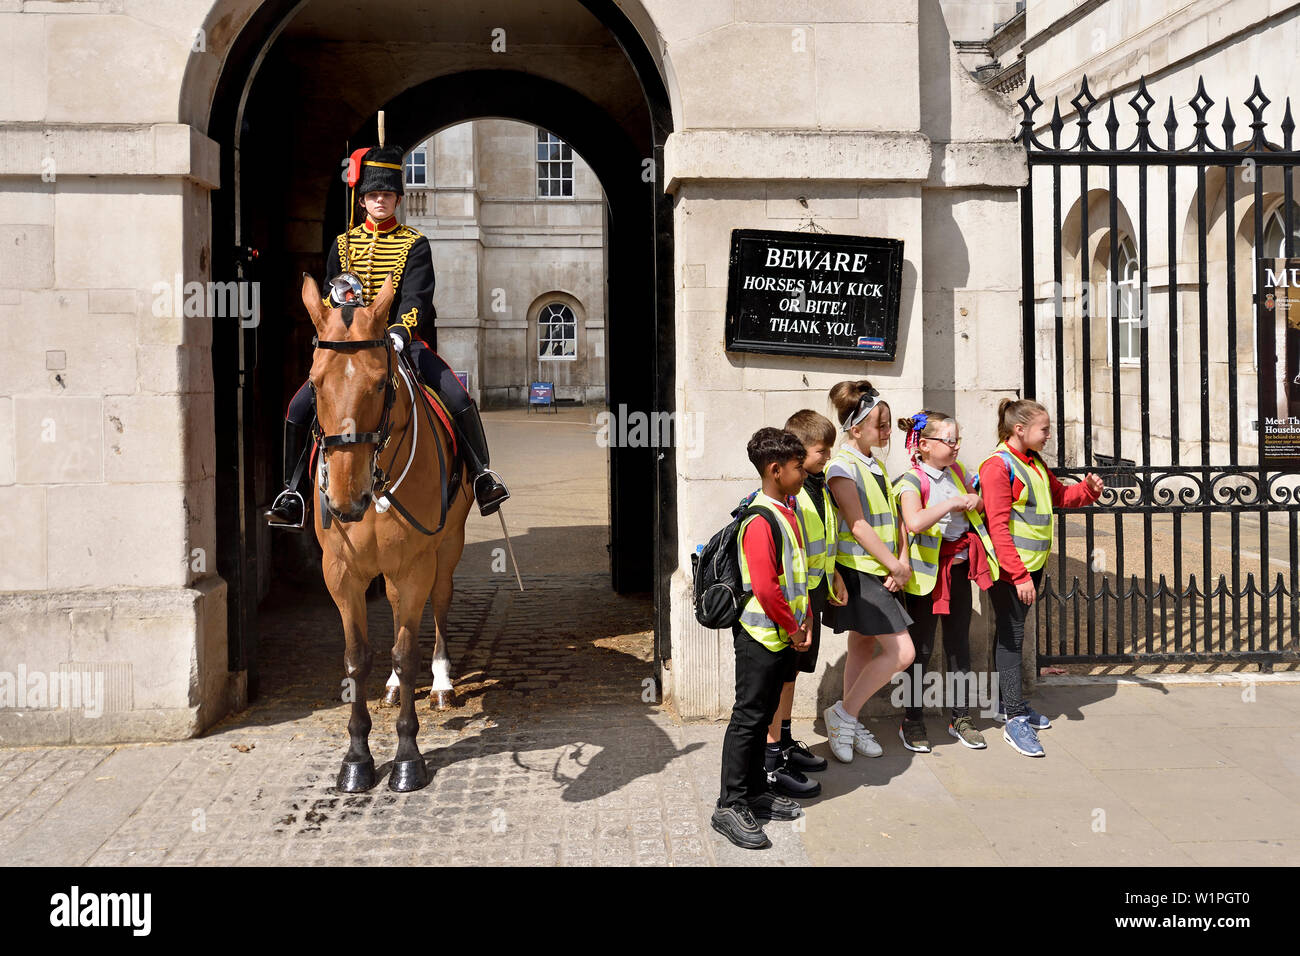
[0,408,806,866]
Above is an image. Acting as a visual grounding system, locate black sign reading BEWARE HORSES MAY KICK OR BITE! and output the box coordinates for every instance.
[727,229,904,362]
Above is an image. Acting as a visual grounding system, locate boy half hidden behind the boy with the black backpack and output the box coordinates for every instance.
[763,408,845,797]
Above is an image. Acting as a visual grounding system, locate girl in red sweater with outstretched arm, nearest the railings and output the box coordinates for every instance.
[979,398,1105,757]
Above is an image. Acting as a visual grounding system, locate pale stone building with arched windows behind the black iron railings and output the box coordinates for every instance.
[958,0,1300,464]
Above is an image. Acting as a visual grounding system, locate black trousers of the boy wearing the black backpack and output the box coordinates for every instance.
[718,624,794,806]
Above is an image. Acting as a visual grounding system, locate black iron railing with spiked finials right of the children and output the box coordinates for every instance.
[1018,78,1300,669]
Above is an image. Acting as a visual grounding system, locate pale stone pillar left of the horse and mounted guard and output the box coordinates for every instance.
[0,122,244,745]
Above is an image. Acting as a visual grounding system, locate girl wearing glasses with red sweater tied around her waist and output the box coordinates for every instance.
[894,410,998,753]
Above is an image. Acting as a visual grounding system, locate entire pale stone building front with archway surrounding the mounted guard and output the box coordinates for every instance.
[10,0,1296,743]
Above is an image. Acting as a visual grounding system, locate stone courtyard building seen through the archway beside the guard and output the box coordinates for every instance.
[399,120,606,408]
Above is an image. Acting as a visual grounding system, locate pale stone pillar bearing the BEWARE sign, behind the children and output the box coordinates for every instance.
[664,0,1024,718]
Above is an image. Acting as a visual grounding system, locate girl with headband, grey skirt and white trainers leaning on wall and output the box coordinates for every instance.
[824,381,915,763]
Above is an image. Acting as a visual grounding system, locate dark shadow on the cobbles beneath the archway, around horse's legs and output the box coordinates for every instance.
[207,525,702,801]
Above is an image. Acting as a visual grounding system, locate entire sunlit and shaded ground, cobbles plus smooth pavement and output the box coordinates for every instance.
[0,410,1300,866]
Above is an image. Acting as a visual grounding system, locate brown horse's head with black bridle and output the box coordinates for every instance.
[303,274,397,522]
